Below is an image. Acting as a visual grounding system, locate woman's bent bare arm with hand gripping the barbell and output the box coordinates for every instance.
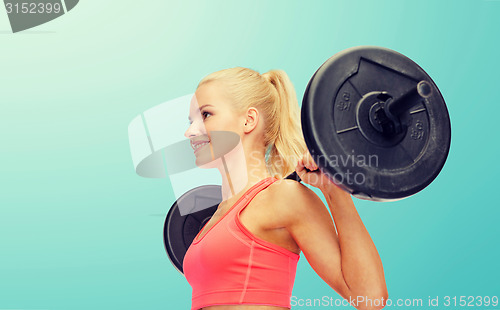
[280,153,388,309]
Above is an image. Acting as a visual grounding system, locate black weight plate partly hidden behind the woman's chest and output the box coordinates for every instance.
[163,185,222,274]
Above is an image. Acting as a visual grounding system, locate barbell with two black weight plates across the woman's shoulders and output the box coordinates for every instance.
[163,46,451,273]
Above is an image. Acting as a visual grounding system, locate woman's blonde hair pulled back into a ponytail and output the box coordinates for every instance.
[198,67,307,178]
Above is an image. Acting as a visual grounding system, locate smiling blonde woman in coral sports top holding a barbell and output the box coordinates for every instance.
[183,68,387,310]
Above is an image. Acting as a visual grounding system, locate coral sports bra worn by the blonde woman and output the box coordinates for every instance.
[183,177,300,310]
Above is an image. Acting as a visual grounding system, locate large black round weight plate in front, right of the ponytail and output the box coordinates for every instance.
[301,46,451,201]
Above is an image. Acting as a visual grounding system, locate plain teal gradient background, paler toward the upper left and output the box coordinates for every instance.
[0,0,500,310]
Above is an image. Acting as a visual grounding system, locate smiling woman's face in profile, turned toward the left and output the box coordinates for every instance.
[184,81,245,166]
